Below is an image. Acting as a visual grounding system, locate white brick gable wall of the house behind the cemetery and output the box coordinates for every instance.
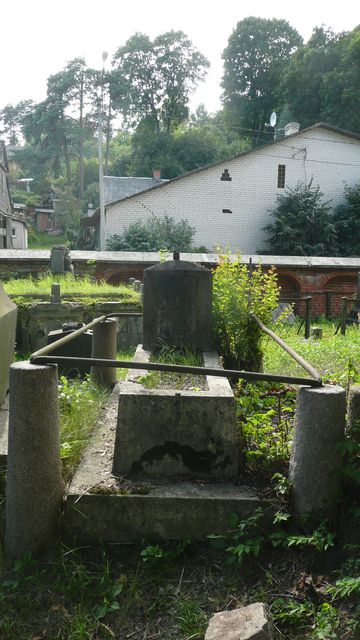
[102,123,360,254]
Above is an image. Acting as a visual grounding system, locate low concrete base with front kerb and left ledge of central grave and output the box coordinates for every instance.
[64,386,271,544]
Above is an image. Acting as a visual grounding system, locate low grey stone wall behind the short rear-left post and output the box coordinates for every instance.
[16,302,142,353]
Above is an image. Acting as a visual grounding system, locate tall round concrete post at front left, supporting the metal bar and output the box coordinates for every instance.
[5,362,64,559]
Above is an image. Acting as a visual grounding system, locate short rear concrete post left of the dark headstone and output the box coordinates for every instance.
[90,318,117,389]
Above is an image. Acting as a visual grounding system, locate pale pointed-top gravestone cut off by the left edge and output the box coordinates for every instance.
[0,284,17,406]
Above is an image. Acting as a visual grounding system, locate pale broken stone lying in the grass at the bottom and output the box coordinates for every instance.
[205,602,274,640]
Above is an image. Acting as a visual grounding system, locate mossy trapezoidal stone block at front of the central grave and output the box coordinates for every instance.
[113,347,240,478]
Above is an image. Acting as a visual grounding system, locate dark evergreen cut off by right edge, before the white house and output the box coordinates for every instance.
[334,182,360,256]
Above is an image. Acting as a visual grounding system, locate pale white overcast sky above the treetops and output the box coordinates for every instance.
[0,0,360,112]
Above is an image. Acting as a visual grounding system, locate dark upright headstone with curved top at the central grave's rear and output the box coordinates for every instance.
[143,260,212,351]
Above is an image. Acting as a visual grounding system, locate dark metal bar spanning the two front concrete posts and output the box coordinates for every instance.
[30,354,322,387]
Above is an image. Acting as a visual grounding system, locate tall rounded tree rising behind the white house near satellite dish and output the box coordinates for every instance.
[222,17,302,142]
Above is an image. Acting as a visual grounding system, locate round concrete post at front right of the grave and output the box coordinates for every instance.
[290,385,346,516]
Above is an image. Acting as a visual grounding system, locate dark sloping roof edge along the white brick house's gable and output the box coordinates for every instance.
[103,122,360,209]
